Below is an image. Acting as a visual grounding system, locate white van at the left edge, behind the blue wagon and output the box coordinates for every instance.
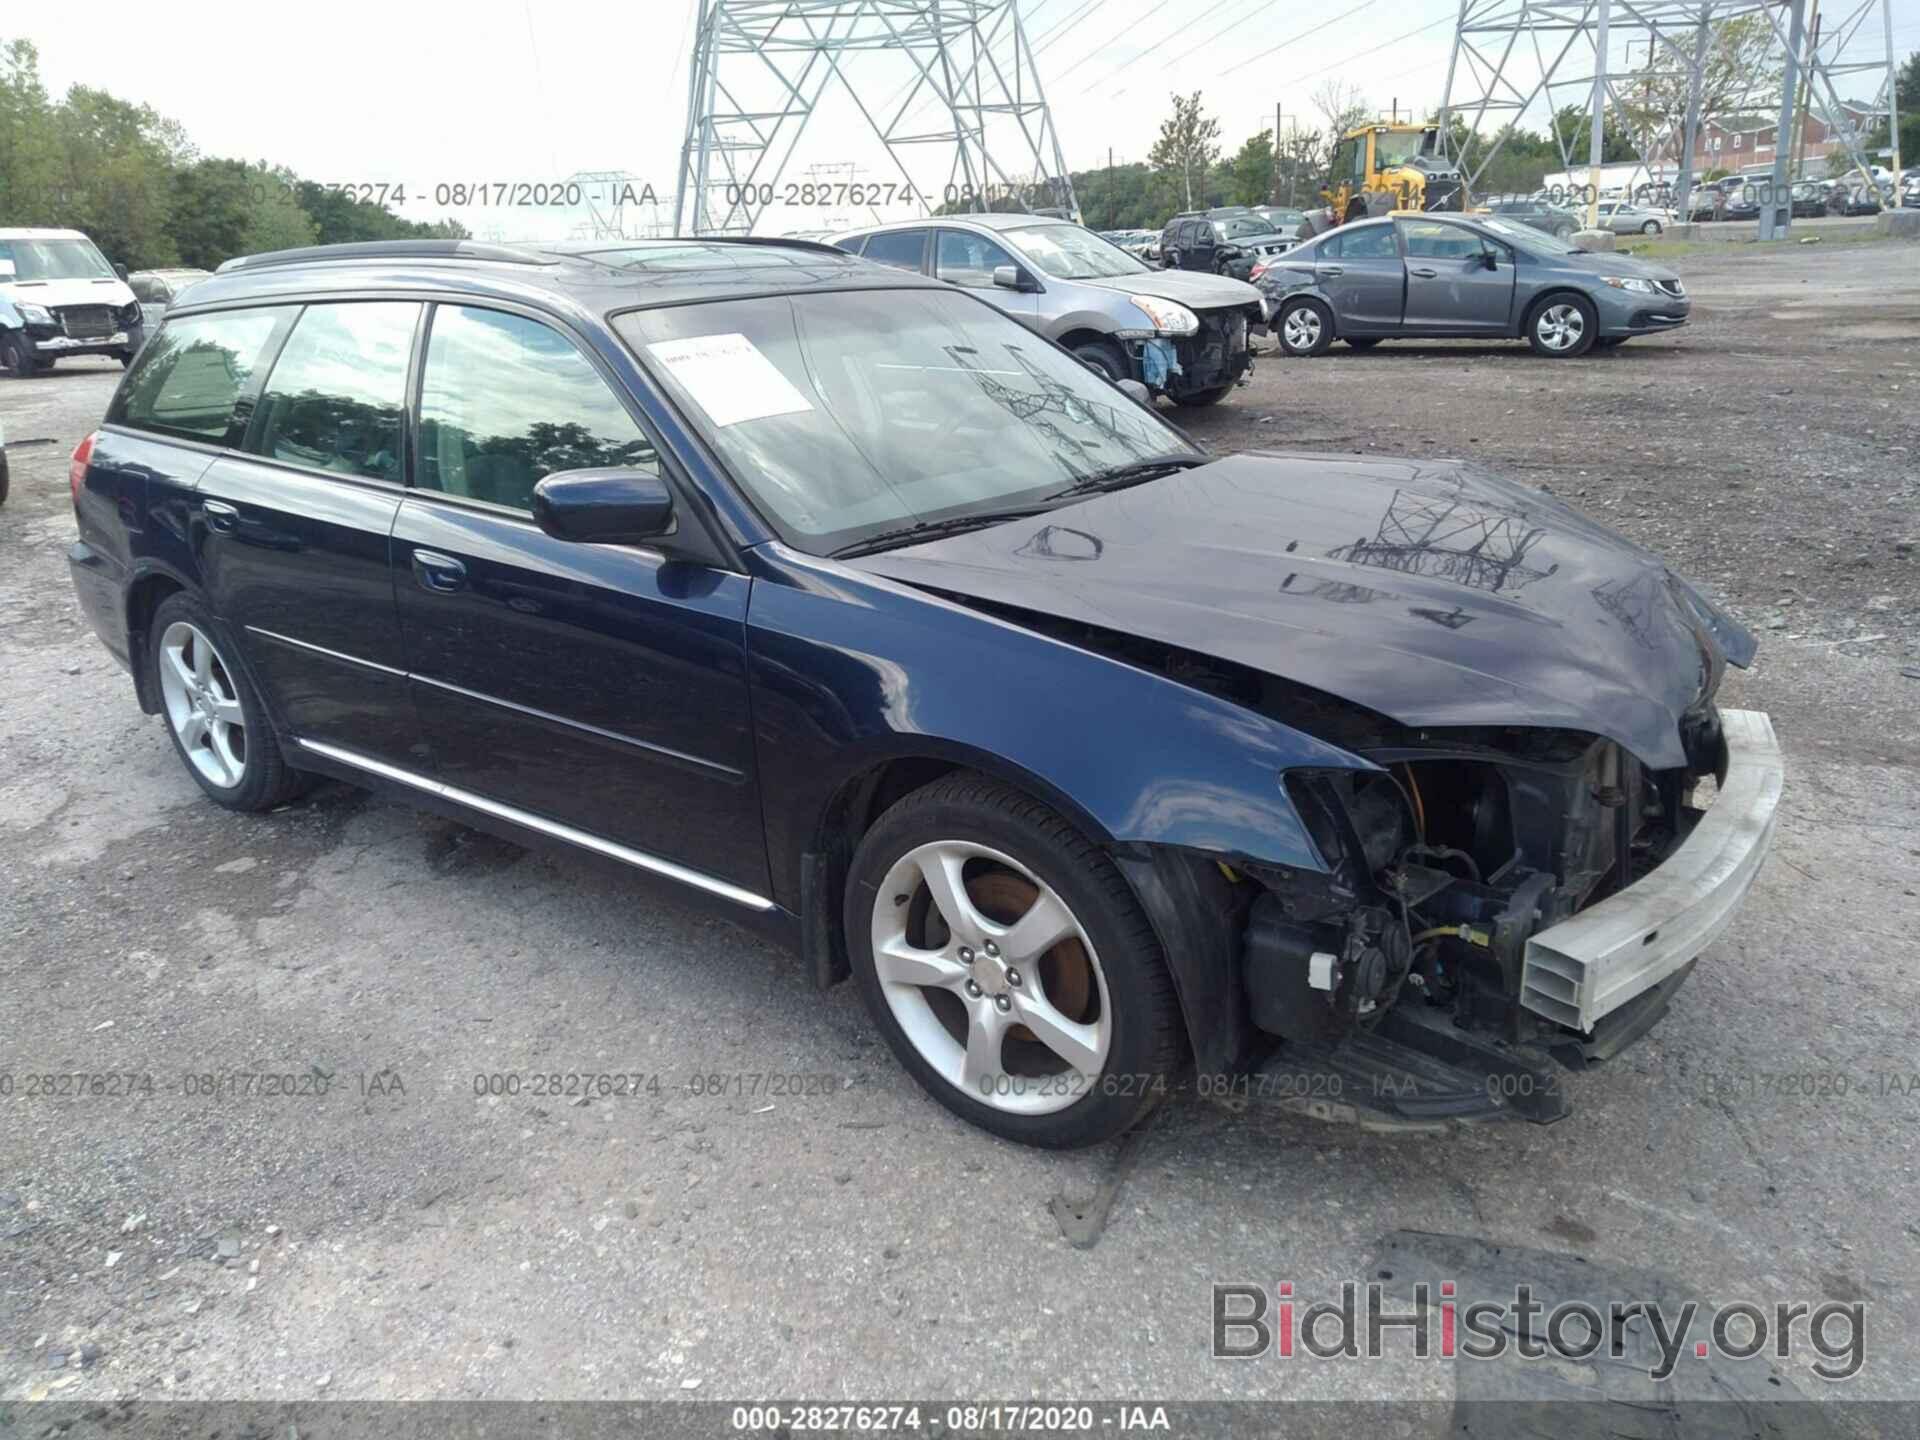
[0,230,146,376]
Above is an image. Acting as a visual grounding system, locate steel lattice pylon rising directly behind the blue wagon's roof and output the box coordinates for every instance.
[674,0,1077,234]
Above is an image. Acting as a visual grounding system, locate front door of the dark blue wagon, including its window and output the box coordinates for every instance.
[394,305,766,895]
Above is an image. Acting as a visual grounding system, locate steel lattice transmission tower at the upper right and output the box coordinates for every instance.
[1440,0,1899,229]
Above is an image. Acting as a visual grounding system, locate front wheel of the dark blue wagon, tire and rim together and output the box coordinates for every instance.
[845,774,1185,1150]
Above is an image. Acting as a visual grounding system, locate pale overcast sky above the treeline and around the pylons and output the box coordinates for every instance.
[18,0,1920,238]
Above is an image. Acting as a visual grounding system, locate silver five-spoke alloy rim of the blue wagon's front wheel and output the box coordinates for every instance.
[872,841,1114,1116]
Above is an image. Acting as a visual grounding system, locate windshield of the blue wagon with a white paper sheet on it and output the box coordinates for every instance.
[614,284,1196,555]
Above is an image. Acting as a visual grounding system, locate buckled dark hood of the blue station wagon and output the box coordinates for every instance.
[849,451,1753,768]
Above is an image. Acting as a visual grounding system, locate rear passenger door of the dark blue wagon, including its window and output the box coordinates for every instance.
[192,300,424,764]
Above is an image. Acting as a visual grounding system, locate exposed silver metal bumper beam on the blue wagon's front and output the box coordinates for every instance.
[1521,710,1782,1033]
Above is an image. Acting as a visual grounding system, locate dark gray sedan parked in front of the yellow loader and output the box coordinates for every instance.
[1254,215,1692,359]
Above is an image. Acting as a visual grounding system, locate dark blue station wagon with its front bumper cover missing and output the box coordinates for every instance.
[71,240,1780,1146]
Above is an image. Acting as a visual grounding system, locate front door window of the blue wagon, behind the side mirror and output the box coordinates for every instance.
[415,305,659,511]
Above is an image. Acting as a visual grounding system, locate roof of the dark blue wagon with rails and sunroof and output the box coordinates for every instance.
[176,236,939,313]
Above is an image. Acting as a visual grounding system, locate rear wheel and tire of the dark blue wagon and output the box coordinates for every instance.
[148,591,305,810]
